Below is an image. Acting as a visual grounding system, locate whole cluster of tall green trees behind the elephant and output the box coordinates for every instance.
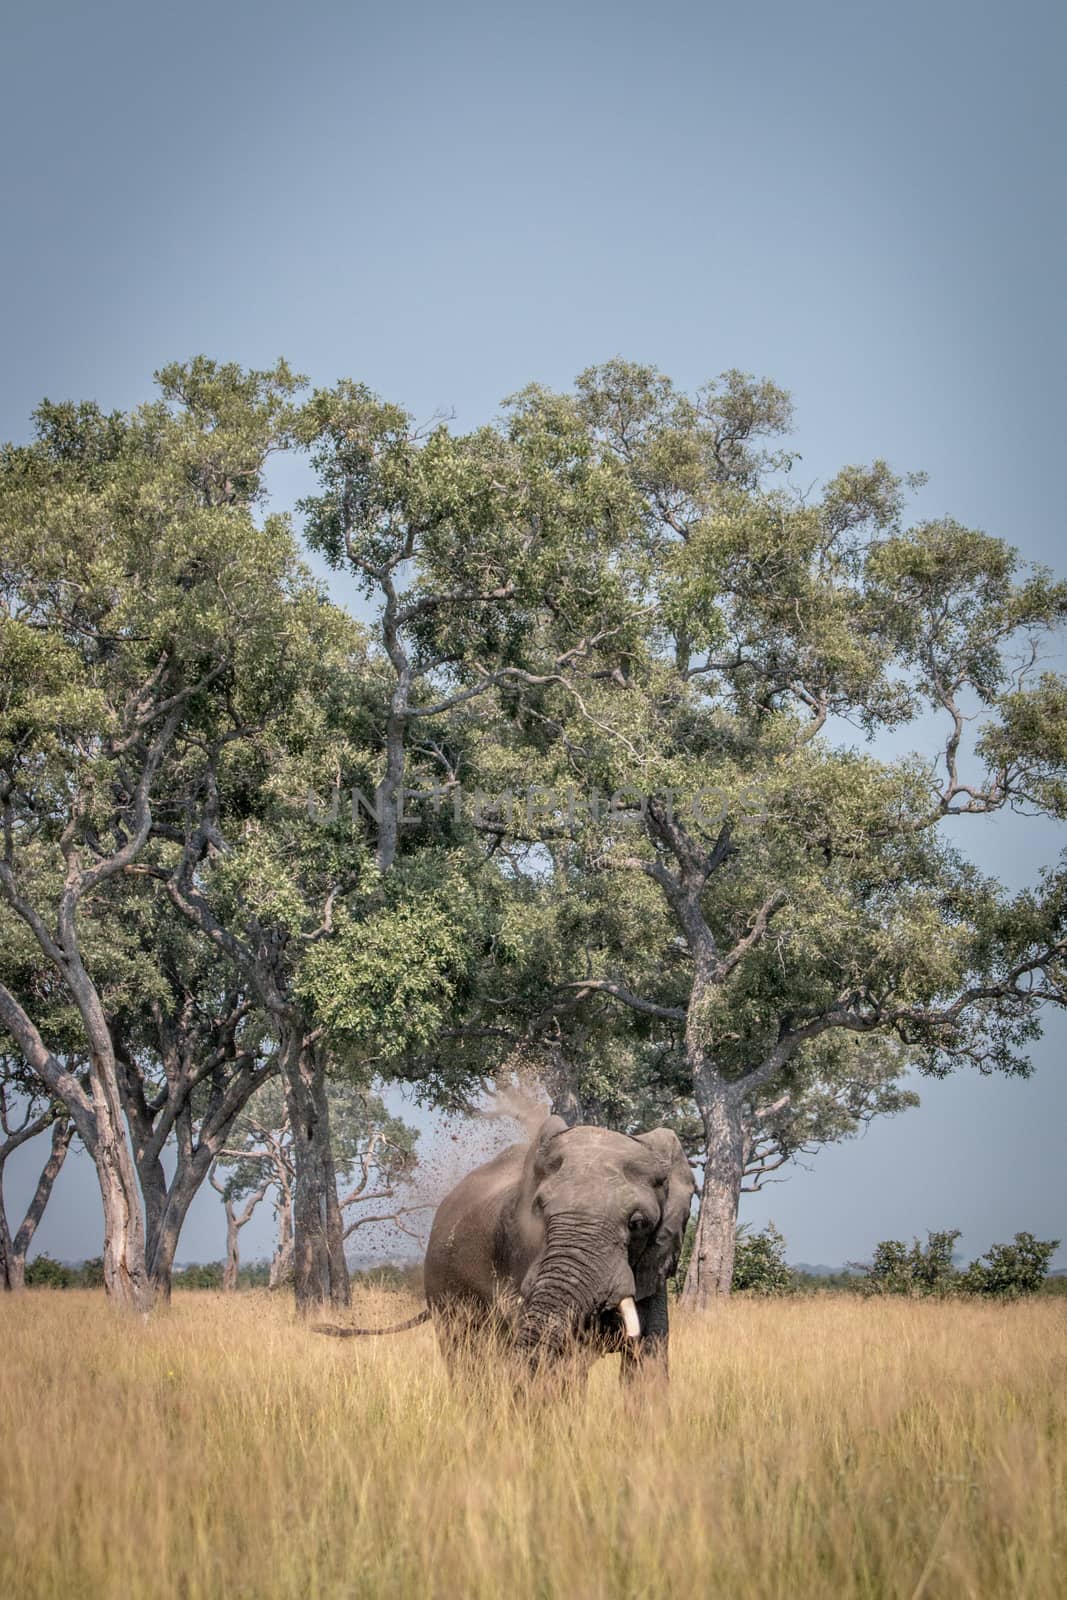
[0,358,1067,1304]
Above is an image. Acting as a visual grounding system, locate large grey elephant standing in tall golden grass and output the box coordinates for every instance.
[426,1117,694,1376]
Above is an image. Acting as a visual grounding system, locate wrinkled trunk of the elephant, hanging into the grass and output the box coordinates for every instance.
[518,1213,640,1355]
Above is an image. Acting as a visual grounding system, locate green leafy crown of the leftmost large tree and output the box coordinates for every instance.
[0,358,338,1050]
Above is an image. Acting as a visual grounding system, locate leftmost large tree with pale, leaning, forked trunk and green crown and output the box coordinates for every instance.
[0,362,310,1309]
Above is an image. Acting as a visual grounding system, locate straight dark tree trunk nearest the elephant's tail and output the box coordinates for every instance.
[285,1040,349,1310]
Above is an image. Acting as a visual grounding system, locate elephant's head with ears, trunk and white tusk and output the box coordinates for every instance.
[517,1117,694,1354]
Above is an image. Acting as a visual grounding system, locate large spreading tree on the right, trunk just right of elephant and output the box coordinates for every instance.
[369,363,1067,1306]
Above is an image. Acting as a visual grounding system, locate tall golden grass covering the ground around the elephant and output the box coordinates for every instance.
[0,1291,1067,1600]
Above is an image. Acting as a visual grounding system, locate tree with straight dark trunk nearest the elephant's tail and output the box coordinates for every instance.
[144,611,390,1309]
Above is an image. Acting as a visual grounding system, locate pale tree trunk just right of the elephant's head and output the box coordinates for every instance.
[681,1069,745,1310]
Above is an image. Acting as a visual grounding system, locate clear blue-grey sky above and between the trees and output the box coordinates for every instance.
[0,0,1067,1264]
